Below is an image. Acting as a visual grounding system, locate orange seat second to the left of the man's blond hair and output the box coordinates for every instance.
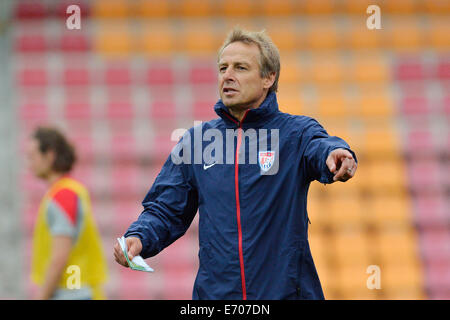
[139,22,178,55]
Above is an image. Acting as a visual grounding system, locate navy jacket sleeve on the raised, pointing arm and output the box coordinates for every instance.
[301,118,358,183]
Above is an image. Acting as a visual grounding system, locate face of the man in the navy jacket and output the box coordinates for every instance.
[219,42,274,109]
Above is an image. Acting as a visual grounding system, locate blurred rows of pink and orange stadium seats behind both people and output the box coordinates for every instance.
[0,0,450,299]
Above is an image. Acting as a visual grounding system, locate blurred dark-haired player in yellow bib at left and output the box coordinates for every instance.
[27,127,107,300]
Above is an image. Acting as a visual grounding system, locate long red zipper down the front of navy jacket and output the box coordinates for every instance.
[234,110,248,300]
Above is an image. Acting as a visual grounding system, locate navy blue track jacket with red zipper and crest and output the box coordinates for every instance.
[125,93,356,299]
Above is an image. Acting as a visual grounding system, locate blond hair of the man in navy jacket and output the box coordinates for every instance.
[217,27,281,92]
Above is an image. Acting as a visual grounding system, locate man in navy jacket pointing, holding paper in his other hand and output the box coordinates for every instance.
[114,29,357,300]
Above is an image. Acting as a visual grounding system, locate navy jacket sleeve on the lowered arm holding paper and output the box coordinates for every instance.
[124,146,198,258]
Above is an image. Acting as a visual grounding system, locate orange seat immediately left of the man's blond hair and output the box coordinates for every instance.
[179,21,222,55]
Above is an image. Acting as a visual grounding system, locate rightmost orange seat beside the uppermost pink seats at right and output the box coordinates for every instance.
[349,53,390,83]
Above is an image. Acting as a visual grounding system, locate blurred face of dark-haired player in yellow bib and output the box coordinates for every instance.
[27,138,54,179]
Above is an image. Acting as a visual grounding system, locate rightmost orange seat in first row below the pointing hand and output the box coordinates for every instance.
[364,194,411,230]
